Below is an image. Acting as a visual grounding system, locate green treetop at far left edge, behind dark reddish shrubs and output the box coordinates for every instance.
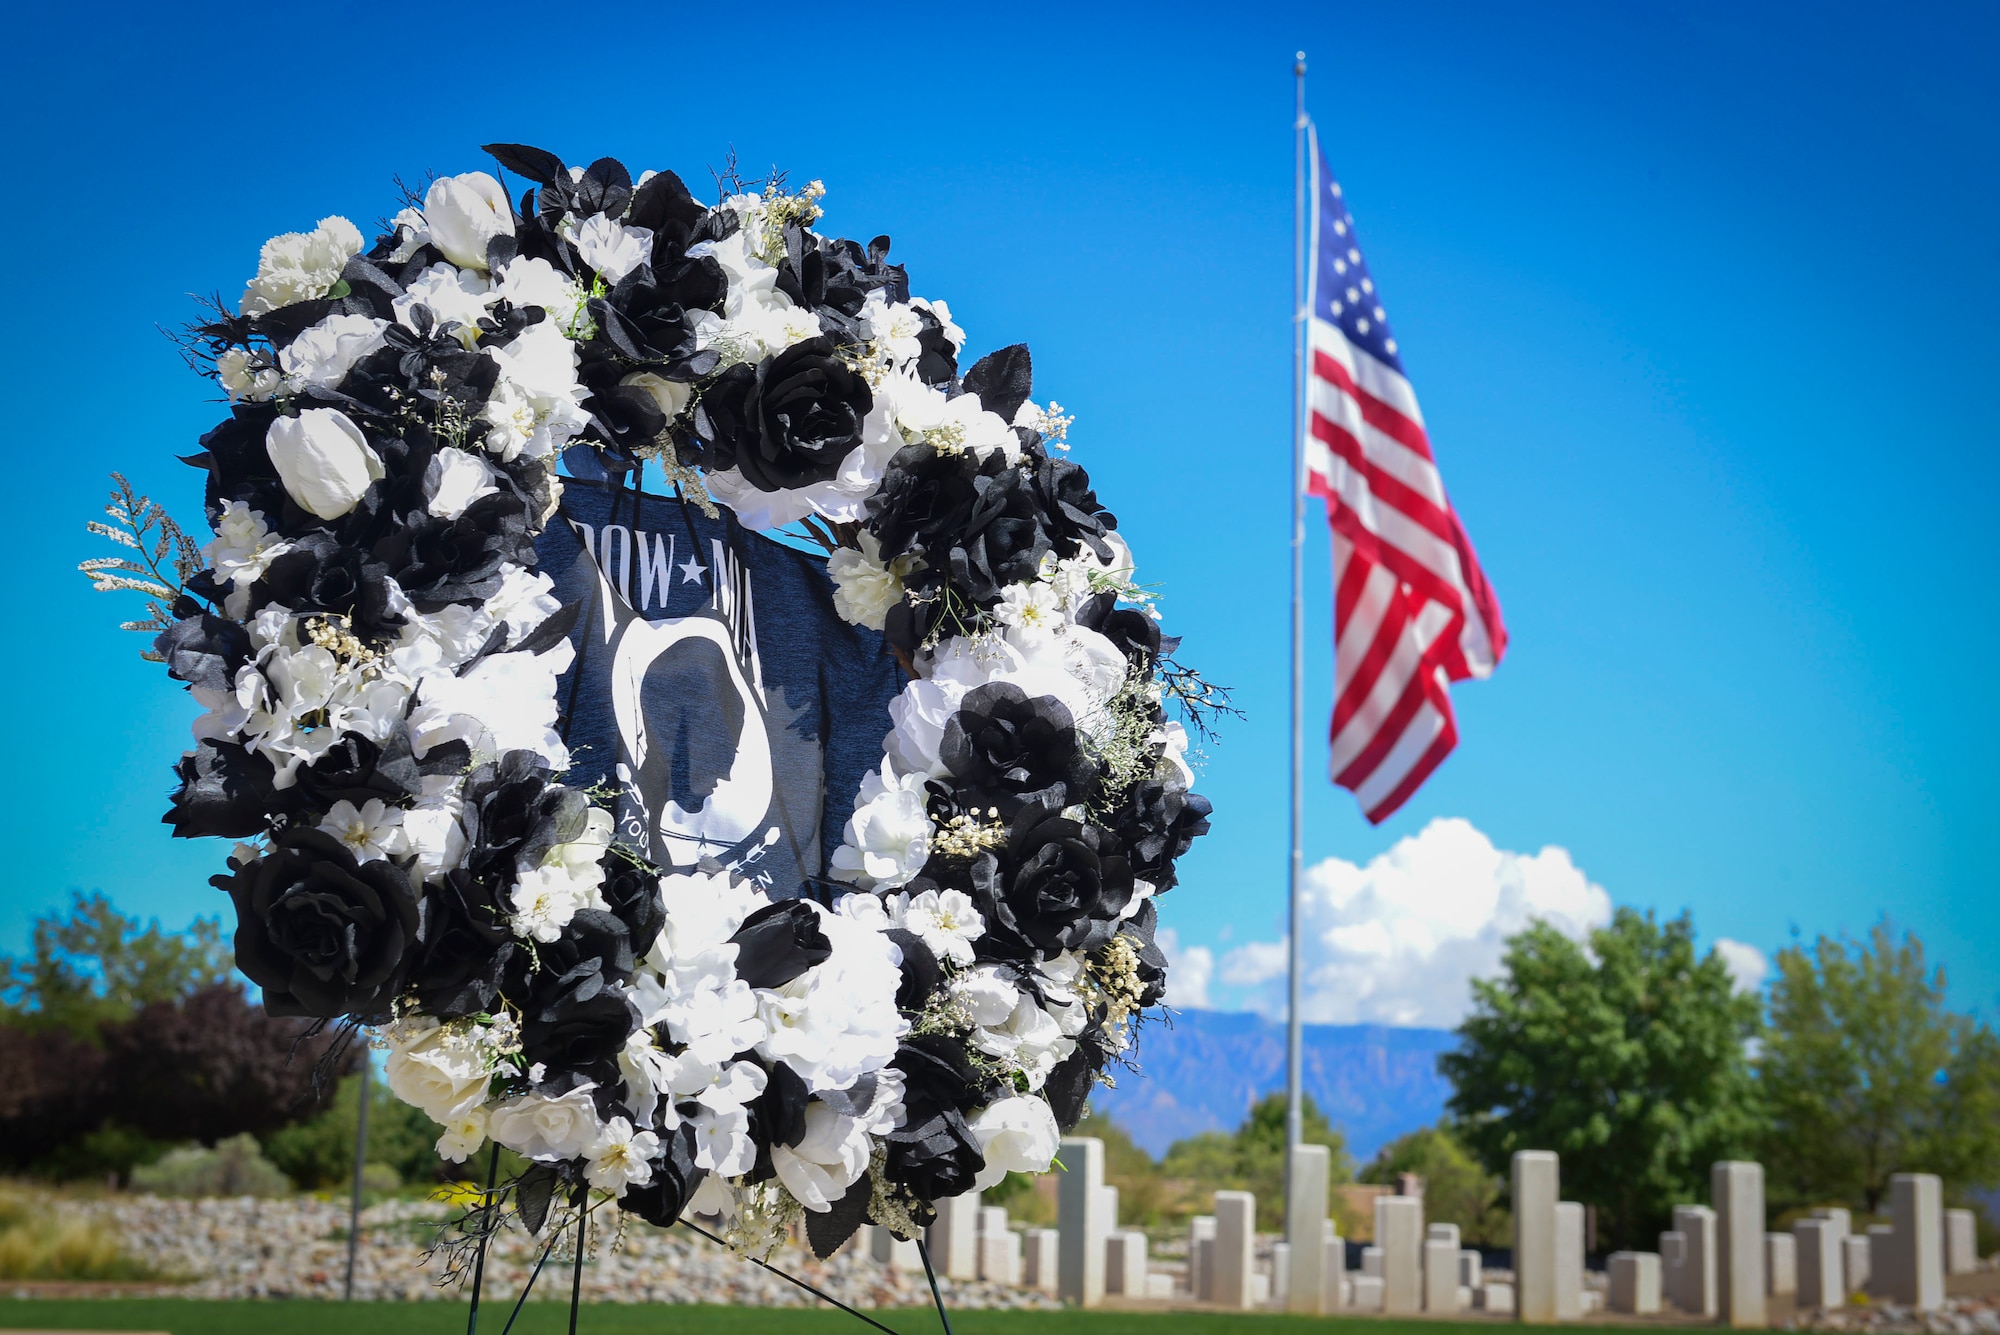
[0,893,234,1041]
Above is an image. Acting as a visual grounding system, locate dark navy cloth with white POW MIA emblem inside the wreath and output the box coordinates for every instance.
[536,478,902,897]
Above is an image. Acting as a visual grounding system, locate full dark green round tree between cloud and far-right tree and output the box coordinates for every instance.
[1438,909,1764,1247]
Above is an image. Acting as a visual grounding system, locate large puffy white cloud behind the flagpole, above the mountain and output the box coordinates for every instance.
[1208,819,1616,1027]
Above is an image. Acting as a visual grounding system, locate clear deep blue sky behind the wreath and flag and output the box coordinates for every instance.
[0,4,2000,1015]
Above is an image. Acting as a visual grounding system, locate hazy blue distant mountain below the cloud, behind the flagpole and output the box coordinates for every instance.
[1092,1011,1458,1165]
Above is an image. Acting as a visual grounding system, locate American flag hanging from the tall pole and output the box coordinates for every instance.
[1304,134,1506,821]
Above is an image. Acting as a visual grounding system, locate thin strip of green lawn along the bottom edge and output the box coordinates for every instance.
[0,1299,1630,1335]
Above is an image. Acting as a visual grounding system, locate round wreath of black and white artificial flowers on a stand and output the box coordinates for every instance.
[86,144,1218,1255]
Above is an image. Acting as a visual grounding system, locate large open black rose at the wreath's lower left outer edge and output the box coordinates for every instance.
[210,827,422,1019]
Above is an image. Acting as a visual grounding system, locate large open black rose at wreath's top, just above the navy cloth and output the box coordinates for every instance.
[704,338,874,492]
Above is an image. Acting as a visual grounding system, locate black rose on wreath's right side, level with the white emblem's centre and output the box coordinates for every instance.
[942,681,1096,815]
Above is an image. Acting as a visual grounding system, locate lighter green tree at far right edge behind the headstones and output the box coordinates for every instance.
[1758,921,2000,1213]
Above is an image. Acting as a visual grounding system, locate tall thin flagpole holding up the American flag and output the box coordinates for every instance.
[1284,52,1310,1175]
